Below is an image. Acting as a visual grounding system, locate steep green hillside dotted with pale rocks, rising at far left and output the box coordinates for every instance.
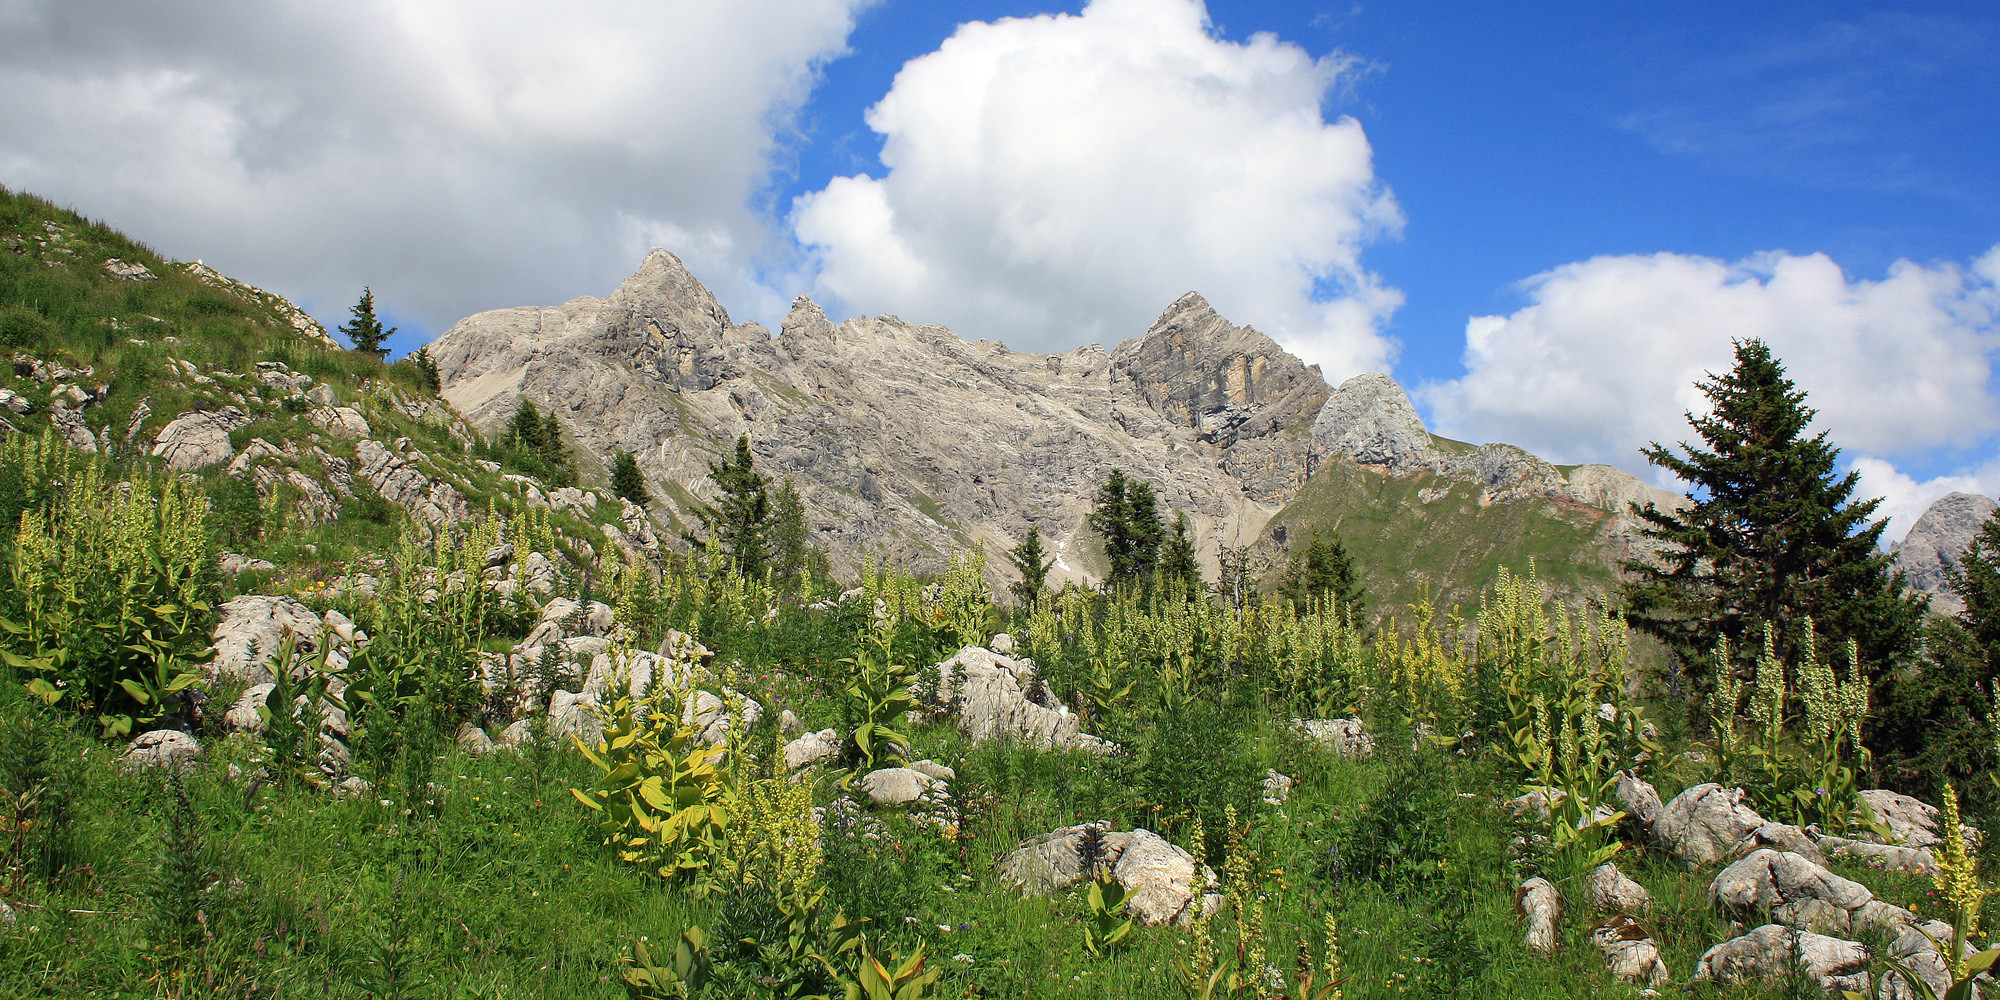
[0,188,632,586]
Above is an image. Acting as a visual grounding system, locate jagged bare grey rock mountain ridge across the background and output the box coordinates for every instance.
[430,250,1678,596]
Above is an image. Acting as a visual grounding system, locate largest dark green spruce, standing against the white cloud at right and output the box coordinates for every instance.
[1624,340,1924,694]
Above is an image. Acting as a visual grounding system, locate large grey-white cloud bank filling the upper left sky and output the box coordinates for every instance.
[0,0,868,340]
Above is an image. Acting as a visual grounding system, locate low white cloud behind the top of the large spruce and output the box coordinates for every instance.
[1418,246,2000,482]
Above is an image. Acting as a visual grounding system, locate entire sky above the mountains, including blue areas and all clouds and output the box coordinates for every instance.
[0,0,2000,534]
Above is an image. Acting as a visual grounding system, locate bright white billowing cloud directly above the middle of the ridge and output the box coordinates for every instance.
[794,0,1400,380]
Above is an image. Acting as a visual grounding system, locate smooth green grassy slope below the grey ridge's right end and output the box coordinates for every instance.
[1260,460,1618,612]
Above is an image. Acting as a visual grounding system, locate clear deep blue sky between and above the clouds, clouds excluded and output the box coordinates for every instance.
[774,0,2000,382]
